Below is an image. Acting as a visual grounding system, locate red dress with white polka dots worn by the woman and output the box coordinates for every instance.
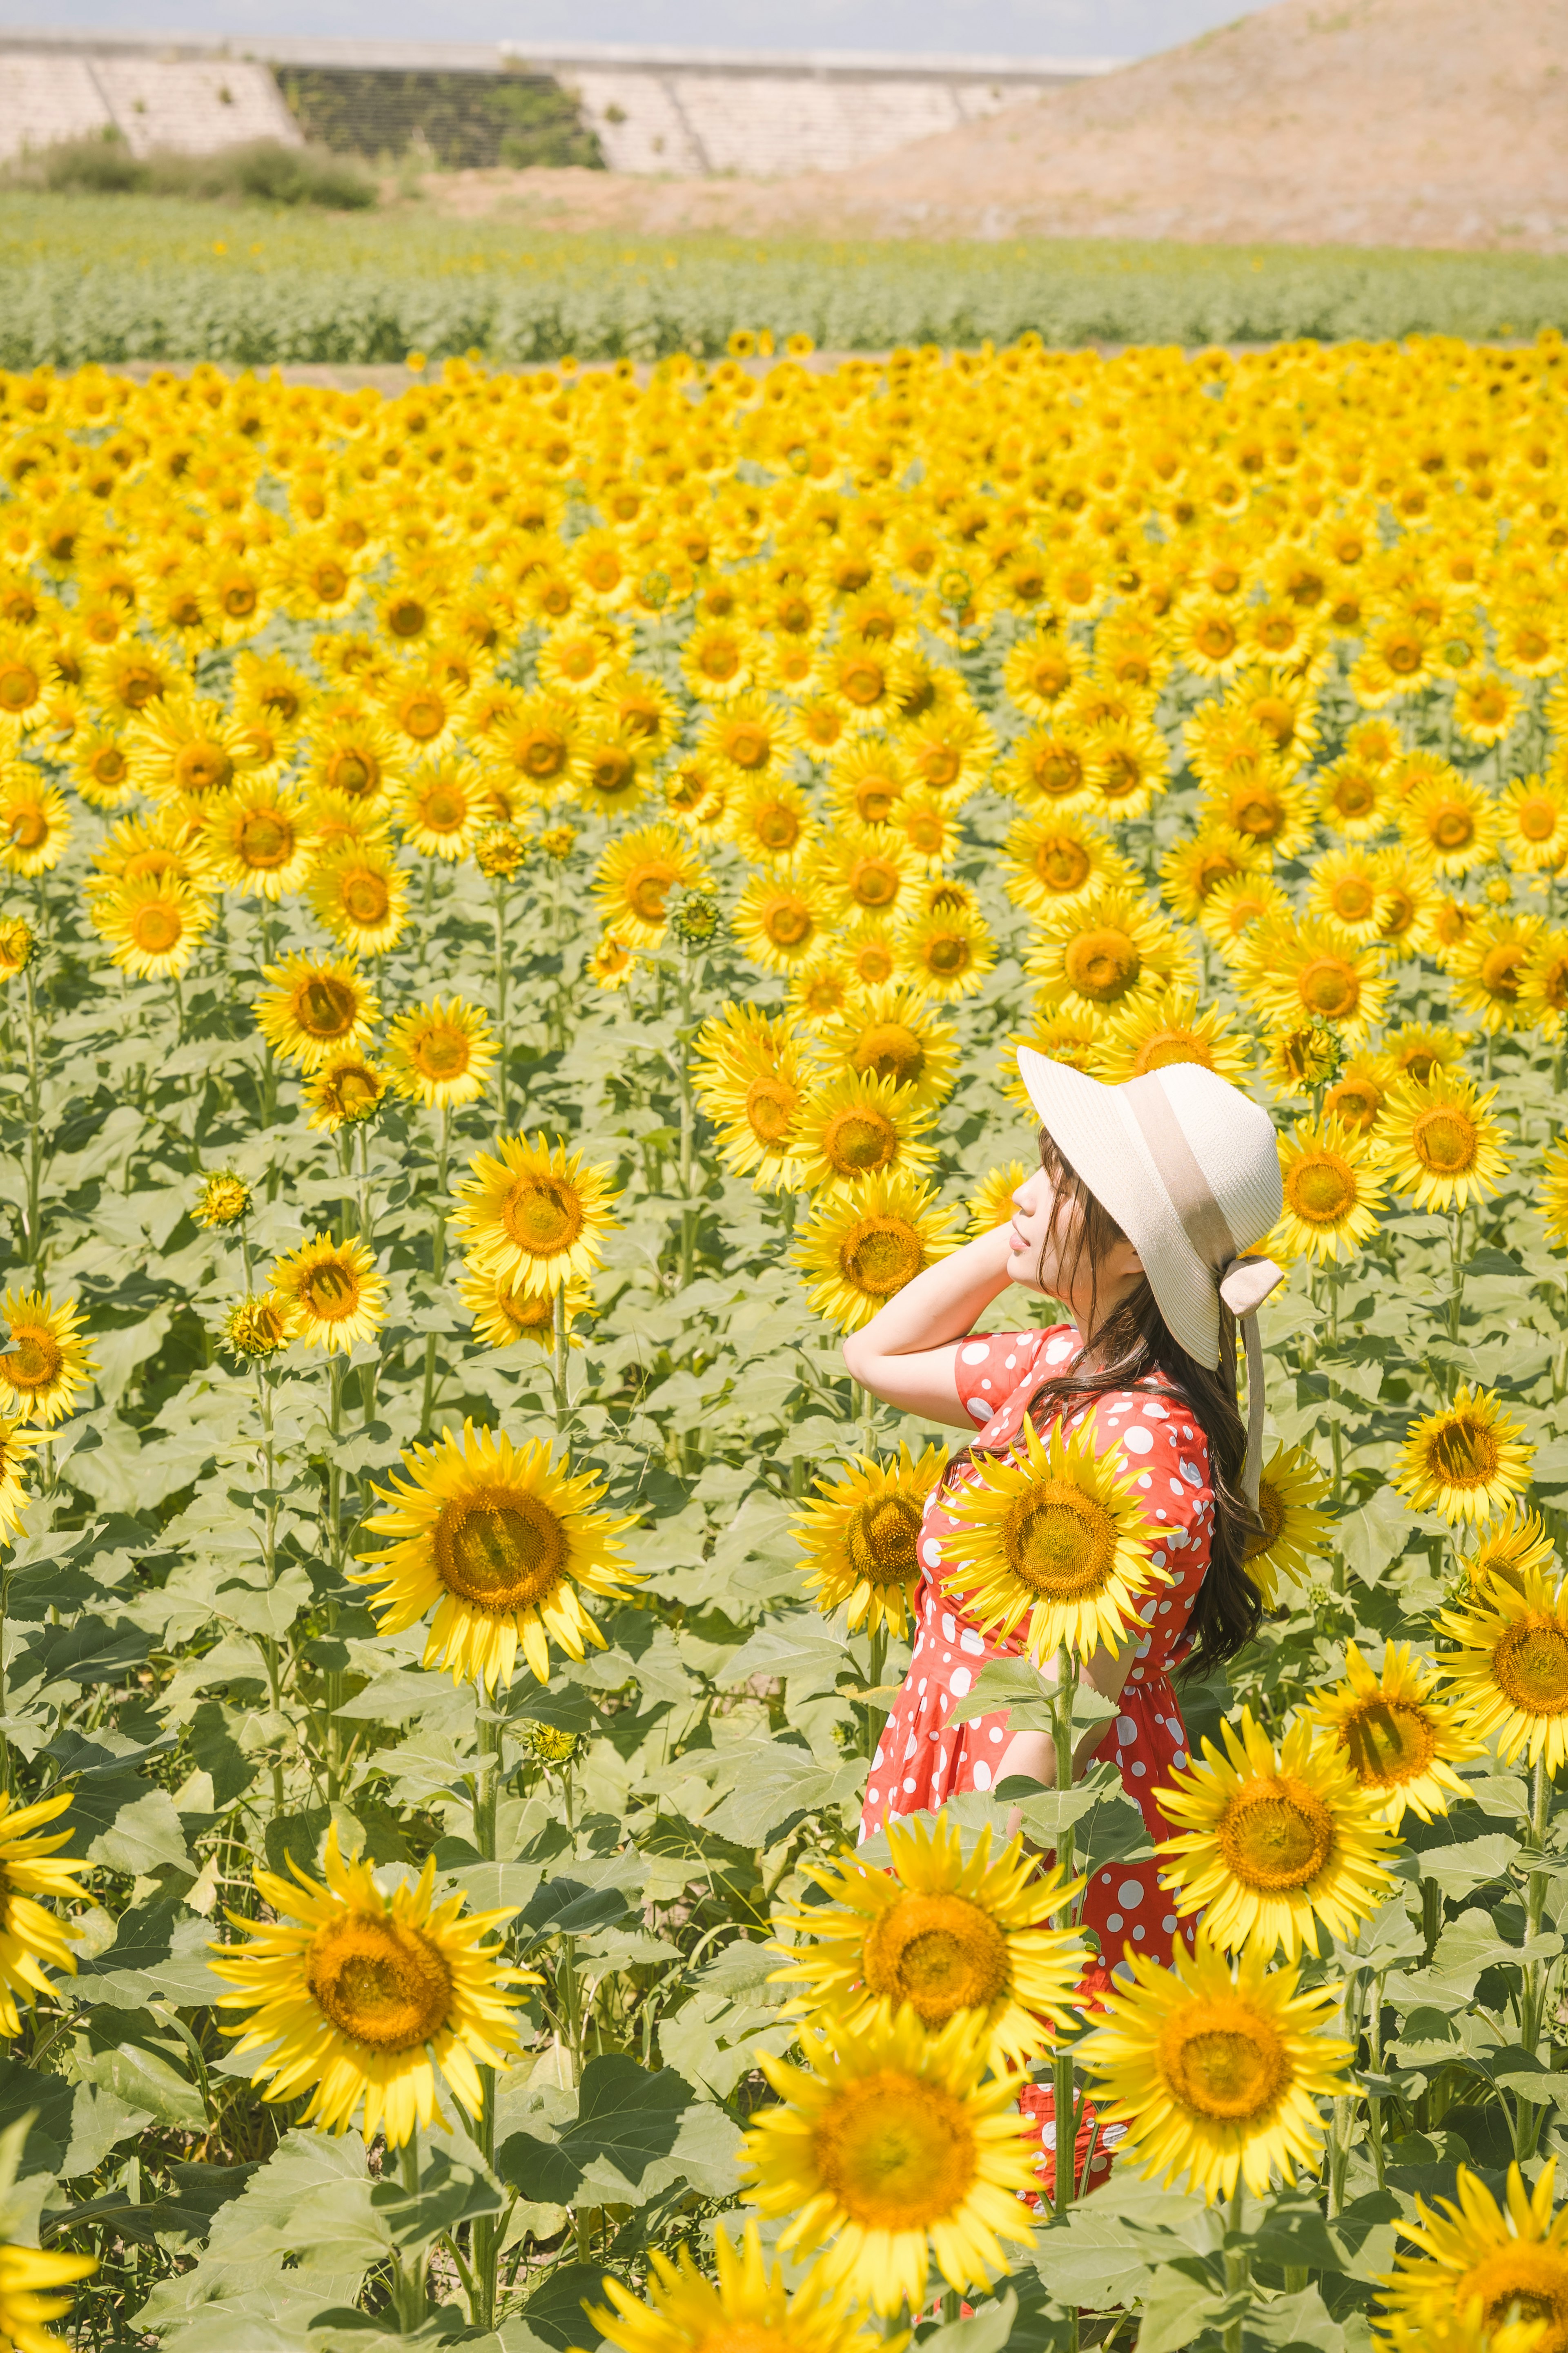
[860,1325,1213,2181]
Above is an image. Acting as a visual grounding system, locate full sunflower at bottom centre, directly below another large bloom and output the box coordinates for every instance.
[745,2010,1039,2315]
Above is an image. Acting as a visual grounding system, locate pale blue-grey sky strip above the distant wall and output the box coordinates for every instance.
[0,0,1265,56]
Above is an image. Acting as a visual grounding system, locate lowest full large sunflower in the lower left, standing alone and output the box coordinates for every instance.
[209,1824,538,2148]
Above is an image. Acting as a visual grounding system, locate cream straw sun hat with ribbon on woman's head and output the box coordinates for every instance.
[1018,1045,1283,1506]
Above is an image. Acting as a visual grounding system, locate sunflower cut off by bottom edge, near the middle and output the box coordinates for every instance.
[583,2219,889,2353]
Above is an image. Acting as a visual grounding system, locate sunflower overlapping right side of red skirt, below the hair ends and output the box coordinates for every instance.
[1154,1708,1394,1963]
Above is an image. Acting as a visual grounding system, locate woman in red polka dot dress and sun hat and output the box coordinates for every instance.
[844,1047,1281,2167]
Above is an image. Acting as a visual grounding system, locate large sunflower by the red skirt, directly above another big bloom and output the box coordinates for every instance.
[773,1807,1086,2075]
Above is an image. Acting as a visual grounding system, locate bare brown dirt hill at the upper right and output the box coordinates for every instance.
[432,0,1568,252]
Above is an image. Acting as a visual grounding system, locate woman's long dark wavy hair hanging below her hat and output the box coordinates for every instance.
[968,1127,1263,1678]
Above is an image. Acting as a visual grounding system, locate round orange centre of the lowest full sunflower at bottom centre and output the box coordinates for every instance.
[811,2068,978,2230]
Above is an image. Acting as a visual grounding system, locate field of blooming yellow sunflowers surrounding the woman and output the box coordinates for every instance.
[0,332,1568,2353]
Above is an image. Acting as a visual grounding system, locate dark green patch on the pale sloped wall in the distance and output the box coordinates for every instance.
[277,66,604,172]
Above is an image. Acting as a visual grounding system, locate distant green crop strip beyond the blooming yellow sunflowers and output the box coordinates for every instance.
[0,195,1568,367]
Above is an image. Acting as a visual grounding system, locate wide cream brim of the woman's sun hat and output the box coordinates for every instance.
[1018,1045,1220,1365]
